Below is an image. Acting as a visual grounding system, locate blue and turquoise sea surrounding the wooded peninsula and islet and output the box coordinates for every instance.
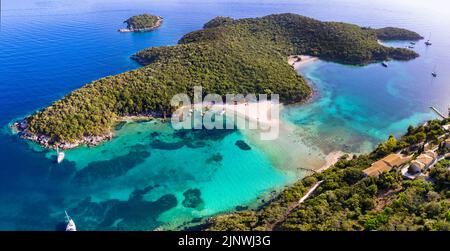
[0,0,450,230]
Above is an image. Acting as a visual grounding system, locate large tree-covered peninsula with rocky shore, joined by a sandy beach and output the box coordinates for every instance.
[16,14,421,148]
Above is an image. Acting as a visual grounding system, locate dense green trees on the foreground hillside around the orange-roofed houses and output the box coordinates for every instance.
[208,120,450,231]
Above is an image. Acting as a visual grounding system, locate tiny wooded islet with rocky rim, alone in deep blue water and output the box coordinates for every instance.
[119,14,163,32]
